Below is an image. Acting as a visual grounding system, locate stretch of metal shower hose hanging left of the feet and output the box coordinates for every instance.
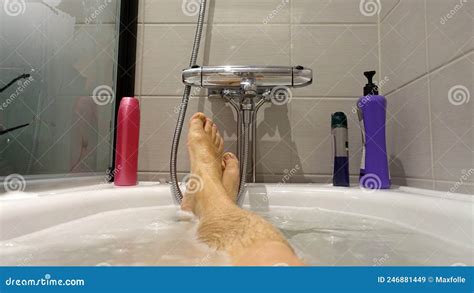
[170,0,207,203]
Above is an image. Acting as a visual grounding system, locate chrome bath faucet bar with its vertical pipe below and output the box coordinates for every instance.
[183,66,313,182]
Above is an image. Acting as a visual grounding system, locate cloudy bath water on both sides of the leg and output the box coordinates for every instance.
[0,206,473,266]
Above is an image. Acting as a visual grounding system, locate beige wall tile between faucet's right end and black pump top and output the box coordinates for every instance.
[291,25,379,97]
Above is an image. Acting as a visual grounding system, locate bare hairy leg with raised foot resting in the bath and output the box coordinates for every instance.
[188,113,303,265]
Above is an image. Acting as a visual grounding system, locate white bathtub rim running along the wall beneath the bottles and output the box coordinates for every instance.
[0,183,474,244]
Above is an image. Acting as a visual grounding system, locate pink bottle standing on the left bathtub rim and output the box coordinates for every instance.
[114,97,140,186]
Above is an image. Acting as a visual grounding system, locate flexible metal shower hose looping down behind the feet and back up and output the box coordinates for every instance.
[170,0,249,204]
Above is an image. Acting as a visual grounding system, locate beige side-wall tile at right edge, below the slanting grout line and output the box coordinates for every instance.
[430,53,474,181]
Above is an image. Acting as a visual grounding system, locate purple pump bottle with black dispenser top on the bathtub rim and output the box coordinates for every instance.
[357,71,390,189]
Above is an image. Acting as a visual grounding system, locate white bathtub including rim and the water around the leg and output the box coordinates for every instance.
[0,183,474,266]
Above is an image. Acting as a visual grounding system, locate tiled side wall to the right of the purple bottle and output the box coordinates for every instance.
[380,0,474,194]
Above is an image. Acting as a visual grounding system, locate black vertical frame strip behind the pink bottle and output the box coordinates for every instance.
[109,0,139,181]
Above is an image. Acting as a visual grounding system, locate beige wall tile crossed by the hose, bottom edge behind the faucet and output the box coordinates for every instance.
[137,24,290,96]
